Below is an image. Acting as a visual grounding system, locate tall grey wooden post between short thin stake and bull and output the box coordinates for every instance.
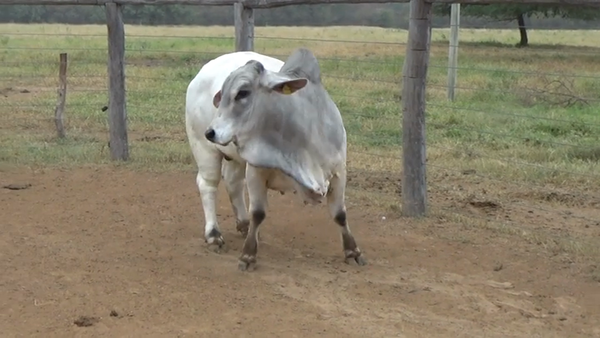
[105,2,129,161]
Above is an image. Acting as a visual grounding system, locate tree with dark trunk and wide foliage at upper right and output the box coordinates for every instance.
[434,4,600,47]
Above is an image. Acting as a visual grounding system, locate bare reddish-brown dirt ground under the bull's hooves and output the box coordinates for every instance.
[0,167,600,338]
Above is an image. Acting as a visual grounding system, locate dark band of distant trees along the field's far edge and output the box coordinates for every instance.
[0,3,600,29]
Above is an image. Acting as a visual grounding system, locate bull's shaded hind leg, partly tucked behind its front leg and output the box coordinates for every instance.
[223,160,250,238]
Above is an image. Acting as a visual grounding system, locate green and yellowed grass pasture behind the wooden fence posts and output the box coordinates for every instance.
[0,25,600,184]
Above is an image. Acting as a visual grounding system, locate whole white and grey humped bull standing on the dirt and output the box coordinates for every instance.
[186,48,366,270]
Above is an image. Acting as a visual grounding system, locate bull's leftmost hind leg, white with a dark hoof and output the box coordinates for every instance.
[190,139,225,250]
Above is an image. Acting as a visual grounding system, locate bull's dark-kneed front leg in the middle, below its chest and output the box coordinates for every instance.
[238,164,267,271]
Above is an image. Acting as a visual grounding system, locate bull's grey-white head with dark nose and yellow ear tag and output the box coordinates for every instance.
[204,60,308,145]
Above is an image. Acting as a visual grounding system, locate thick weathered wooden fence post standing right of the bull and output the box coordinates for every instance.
[402,0,432,217]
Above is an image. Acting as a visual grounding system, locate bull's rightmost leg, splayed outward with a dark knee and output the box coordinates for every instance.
[327,171,367,265]
